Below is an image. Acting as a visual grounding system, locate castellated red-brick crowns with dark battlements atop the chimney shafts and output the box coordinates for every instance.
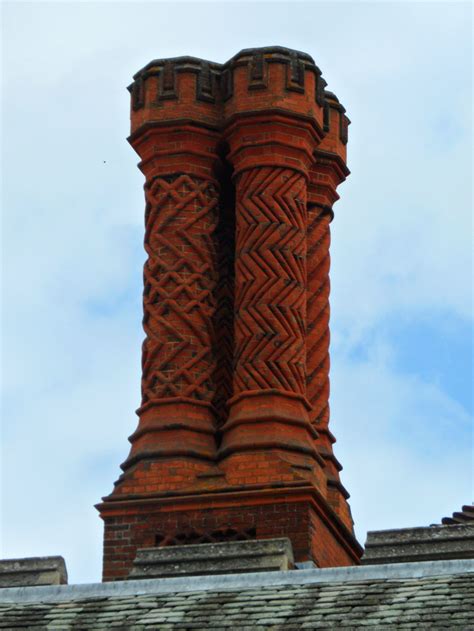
[129,46,349,178]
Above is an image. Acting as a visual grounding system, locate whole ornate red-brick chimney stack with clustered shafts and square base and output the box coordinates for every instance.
[97,47,362,580]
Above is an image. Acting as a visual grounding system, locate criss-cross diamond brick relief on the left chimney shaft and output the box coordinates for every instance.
[142,175,218,405]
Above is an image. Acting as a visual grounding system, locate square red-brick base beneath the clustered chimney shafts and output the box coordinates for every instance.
[102,485,359,581]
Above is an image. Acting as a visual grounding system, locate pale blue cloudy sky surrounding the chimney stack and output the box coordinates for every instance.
[0,1,474,582]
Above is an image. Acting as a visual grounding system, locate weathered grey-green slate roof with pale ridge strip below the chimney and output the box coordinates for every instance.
[0,560,474,631]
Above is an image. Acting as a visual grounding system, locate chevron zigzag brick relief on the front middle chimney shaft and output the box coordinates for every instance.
[234,167,306,394]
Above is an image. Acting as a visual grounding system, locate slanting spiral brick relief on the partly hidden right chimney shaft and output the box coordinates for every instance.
[306,205,331,429]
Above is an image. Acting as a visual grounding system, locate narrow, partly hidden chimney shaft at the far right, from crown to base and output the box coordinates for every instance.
[307,92,352,527]
